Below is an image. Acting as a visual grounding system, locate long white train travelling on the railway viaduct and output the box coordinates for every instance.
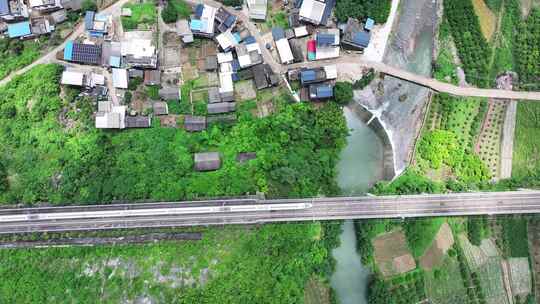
[0,203,313,223]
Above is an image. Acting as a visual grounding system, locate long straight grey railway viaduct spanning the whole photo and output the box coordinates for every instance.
[0,191,540,234]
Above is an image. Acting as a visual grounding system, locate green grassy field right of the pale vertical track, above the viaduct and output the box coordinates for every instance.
[512,102,540,178]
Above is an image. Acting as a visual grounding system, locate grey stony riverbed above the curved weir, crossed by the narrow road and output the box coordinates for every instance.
[354,0,438,179]
